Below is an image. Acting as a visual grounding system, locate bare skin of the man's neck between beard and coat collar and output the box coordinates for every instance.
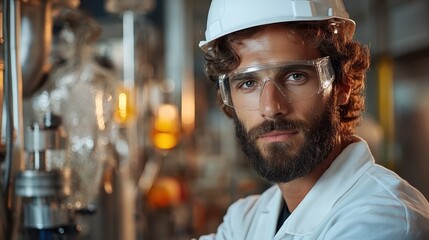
[278,136,352,212]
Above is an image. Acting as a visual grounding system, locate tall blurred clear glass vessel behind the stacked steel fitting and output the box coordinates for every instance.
[31,10,115,210]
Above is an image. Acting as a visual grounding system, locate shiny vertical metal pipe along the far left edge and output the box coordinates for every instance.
[3,1,23,240]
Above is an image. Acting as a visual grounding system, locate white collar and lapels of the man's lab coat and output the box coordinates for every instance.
[270,139,374,236]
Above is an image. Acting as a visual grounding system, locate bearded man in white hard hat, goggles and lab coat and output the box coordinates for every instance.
[196,0,429,240]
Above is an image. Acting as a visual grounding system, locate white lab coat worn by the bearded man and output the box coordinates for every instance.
[196,140,429,240]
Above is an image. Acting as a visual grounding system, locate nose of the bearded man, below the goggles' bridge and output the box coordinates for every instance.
[259,79,289,118]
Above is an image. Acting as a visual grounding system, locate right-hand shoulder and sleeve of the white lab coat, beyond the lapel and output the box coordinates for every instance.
[317,165,429,240]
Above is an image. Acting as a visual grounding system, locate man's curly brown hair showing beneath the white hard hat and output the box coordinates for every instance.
[204,19,370,136]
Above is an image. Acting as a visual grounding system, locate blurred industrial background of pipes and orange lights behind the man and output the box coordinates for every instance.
[0,0,429,240]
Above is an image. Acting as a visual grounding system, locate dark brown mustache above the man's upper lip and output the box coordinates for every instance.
[248,119,310,141]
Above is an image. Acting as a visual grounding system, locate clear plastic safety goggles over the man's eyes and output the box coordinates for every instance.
[219,56,335,110]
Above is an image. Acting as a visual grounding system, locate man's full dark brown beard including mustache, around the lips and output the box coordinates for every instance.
[233,95,340,183]
